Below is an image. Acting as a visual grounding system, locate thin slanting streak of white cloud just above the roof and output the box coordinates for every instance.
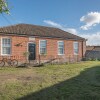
[43,20,77,34]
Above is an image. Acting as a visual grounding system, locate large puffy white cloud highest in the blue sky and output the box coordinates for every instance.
[80,12,100,30]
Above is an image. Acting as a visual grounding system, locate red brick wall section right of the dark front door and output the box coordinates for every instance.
[36,38,86,61]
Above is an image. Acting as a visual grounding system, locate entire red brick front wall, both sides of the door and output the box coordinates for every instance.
[0,36,86,61]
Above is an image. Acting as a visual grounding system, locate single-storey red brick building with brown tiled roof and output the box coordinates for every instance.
[0,24,86,61]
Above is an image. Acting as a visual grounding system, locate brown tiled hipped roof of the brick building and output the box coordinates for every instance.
[0,24,85,40]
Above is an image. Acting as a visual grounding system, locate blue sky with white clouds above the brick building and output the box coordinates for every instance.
[0,0,100,45]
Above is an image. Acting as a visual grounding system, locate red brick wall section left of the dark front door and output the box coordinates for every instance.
[0,36,28,61]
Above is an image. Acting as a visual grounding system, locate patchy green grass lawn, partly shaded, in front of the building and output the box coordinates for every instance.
[0,61,100,100]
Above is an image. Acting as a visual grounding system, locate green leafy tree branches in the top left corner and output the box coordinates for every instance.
[0,0,9,14]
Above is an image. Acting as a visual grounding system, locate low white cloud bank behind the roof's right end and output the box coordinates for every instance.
[81,32,100,45]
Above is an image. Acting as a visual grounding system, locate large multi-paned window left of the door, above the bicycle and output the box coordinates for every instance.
[1,38,11,55]
